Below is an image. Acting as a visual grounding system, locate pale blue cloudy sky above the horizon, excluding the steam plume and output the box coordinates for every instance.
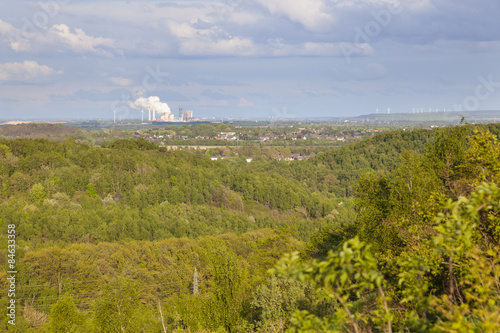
[0,0,500,120]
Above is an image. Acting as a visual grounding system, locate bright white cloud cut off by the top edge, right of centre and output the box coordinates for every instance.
[256,0,333,31]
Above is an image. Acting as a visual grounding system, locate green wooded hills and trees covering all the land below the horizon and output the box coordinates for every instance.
[0,123,500,333]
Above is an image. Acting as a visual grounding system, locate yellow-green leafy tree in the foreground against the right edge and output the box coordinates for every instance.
[399,183,500,332]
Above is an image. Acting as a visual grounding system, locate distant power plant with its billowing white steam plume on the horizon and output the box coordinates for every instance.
[129,96,194,122]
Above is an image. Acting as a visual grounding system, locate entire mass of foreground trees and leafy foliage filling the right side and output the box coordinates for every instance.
[275,126,500,332]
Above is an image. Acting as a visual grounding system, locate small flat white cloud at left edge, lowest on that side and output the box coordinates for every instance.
[0,61,62,83]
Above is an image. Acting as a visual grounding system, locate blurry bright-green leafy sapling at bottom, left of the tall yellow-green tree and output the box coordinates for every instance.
[274,237,393,333]
